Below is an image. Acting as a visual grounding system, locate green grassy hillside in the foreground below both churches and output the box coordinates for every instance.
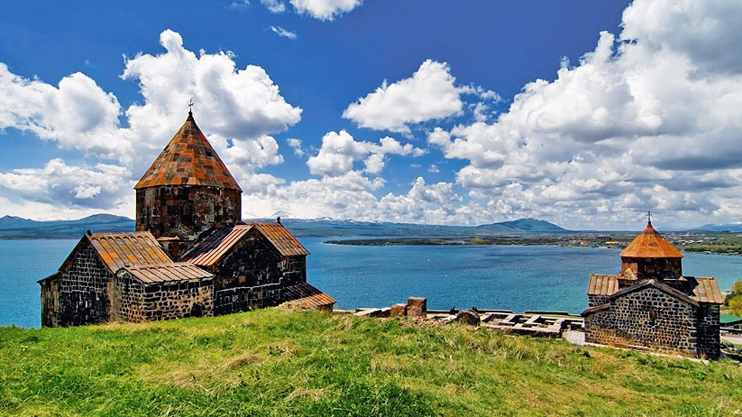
[0,309,742,416]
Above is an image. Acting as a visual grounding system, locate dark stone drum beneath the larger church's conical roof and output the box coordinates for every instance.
[136,186,242,237]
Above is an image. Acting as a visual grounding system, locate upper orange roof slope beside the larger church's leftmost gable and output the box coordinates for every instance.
[85,232,173,272]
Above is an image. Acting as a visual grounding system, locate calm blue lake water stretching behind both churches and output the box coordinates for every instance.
[0,238,742,327]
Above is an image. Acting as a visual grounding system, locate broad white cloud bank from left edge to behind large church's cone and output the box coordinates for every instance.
[0,30,302,217]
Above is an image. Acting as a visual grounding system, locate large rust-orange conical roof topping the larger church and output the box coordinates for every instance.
[134,111,242,191]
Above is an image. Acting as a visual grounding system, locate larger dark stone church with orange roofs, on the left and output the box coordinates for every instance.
[39,111,335,327]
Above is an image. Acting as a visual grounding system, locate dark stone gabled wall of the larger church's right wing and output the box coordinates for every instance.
[211,231,307,315]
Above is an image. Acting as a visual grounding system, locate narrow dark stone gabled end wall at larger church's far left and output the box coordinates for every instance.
[57,243,113,326]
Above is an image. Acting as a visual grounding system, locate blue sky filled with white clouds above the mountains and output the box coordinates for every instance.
[0,0,742,229]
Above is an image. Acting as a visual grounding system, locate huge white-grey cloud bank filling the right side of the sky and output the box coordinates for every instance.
[428,0,742,227]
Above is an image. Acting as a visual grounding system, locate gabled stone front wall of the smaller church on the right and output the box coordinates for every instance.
[585,287,699,356]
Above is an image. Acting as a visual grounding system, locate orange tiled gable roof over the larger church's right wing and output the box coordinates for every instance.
[183,223,309,266]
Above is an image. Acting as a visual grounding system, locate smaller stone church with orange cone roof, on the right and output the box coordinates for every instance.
[582,218,724,359]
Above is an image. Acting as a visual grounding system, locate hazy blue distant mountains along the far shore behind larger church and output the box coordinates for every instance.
[0,214,568,239]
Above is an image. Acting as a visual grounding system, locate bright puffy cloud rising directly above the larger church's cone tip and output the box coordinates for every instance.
[122,30,302,158]
